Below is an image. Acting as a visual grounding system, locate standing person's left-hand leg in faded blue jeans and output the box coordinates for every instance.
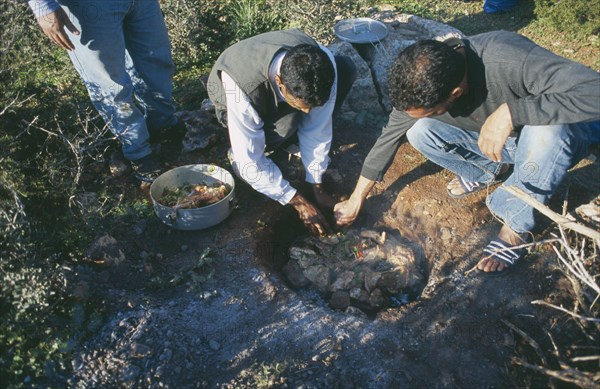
[61,0,152,160]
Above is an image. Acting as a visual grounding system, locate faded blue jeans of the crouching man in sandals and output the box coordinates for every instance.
[406,118,600,234]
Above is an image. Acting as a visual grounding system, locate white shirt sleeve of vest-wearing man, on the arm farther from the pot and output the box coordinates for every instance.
[298,45,338,184]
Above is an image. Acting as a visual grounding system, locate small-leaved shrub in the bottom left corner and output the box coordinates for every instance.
[0,175,70,387]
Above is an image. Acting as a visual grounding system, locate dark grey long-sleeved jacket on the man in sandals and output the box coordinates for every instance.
[361,31,600,181]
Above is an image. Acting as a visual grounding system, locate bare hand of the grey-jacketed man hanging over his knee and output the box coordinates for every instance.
[477,103,513,162]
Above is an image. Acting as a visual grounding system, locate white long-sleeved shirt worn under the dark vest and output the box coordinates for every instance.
[221,45,337,205]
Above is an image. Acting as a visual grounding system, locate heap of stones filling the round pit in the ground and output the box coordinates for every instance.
[283,230,425,312]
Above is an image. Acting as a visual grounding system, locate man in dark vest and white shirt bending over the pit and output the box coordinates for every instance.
[207,29,355,234]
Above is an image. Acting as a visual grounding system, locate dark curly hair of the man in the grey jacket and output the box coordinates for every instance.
[388,40,466,111]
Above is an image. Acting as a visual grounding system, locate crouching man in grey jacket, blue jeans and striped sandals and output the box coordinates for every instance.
[335,31,600,273]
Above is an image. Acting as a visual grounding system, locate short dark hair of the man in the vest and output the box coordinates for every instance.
[280,44,335,107]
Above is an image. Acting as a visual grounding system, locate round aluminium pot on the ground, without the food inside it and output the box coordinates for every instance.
[150,164,235,230]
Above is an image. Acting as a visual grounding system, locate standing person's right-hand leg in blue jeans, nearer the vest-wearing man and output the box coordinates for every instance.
[123,0,177,133]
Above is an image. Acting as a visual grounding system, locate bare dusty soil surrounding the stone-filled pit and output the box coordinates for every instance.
[70,110,598,388]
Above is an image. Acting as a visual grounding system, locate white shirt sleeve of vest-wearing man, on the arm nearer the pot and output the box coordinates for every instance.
[221,72,296,205]
